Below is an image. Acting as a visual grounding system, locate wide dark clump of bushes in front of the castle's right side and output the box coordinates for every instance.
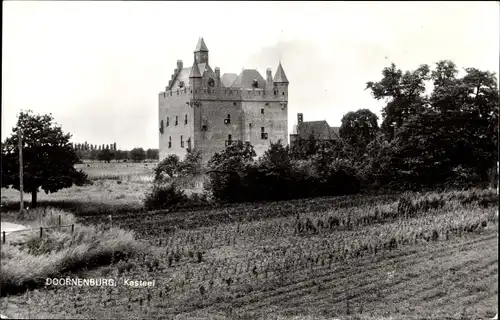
[207,141,360,202]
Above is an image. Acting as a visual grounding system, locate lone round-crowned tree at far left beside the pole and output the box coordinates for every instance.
[2,110,87,207]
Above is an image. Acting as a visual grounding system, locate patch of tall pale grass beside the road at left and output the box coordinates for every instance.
[0,209,146,296]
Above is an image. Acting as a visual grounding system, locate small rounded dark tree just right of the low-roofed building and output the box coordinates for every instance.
[339,109,379,149]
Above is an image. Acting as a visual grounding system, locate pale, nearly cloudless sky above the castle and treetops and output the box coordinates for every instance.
[2,1,500,149]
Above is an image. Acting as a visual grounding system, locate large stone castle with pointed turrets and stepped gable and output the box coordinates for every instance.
[158,38,289,161]
